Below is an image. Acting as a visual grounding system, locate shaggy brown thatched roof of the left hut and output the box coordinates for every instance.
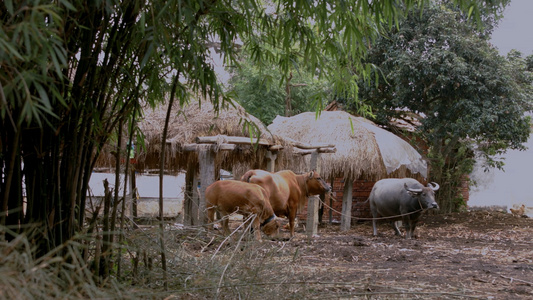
[137,100,283,175]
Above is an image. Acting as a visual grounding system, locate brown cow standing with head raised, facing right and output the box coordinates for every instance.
[241,170,331,237]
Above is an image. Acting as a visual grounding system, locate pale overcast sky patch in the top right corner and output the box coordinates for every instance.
[492,0,533,56]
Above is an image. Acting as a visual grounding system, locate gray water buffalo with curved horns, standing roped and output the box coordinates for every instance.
[368,178,439,238]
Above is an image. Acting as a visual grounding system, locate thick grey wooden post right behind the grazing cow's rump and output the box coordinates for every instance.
[198,145,215,225]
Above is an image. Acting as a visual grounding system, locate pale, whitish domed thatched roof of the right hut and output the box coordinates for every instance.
[268,111,427,180]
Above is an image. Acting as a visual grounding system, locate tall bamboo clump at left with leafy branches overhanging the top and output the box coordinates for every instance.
[0,0,492,254]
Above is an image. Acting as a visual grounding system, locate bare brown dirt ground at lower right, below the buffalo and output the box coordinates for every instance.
[188,211,533,299]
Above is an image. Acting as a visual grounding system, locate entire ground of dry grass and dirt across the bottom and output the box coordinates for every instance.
[5,213,533,299]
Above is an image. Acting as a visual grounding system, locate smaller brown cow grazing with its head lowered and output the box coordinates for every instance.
[205,180,279,241]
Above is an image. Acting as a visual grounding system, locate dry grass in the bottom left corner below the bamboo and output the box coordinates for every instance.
[0,229,135,299]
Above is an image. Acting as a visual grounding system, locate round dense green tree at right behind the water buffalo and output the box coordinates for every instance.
[352,5,533,212]
